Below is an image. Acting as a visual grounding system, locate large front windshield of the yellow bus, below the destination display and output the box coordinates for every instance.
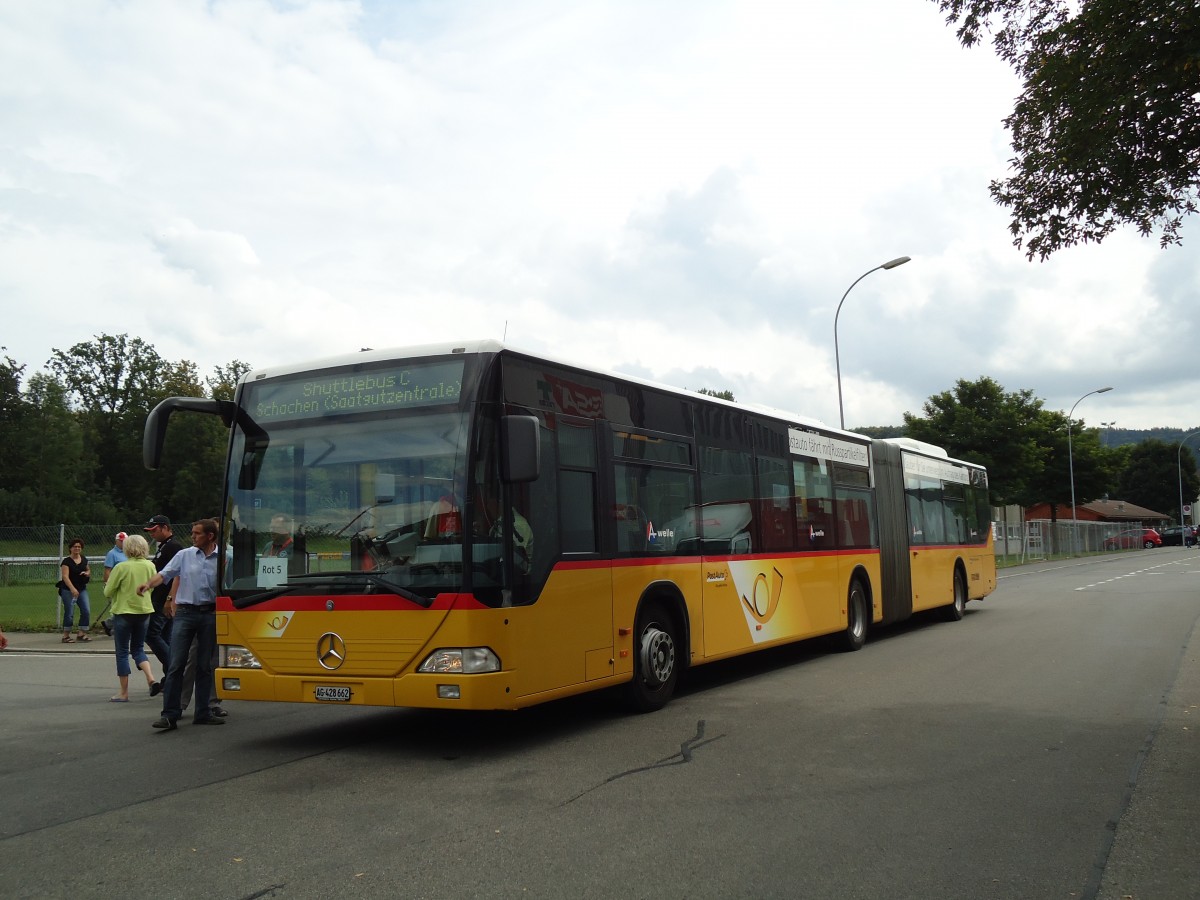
[224,404,475,606]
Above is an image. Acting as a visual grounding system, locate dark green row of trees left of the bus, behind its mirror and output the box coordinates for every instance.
[0,335,248,524]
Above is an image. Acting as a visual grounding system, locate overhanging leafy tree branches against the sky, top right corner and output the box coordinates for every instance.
[935,0,1200,259]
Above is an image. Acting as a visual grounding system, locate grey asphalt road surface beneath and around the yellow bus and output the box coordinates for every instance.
[0,548,1200,900]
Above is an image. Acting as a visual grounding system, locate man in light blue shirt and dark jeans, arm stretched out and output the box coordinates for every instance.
[138,518,224,731]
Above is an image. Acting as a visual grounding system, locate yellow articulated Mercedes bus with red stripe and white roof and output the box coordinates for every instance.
[144,341,996,710]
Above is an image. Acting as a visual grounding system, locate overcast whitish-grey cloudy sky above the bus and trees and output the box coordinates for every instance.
[0,0,1200,428]
